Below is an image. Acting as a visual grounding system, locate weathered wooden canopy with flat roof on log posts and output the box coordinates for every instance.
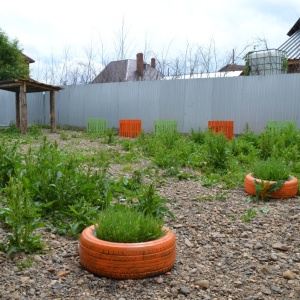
[0,79,63,134]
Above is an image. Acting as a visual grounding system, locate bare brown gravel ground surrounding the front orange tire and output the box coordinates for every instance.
[0,135,300,300]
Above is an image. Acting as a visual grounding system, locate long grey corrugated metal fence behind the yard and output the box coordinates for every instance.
[0,74,300,134]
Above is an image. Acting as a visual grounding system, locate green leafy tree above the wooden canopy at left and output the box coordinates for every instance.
[0,28,29,80]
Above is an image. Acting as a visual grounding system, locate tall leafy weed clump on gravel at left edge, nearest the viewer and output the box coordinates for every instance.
[0,177,44,256]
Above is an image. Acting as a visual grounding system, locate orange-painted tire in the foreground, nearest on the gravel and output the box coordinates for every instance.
[79,225,176,279]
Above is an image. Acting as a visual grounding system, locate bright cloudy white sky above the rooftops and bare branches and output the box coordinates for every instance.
[0,0,300,73]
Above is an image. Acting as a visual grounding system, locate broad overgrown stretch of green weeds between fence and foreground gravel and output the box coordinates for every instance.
[0,124,300,255]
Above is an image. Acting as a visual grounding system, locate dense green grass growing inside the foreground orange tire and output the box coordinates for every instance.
[95,204,165,243]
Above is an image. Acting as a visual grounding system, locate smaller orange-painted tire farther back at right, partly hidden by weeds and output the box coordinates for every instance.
[244,173,298,199]
